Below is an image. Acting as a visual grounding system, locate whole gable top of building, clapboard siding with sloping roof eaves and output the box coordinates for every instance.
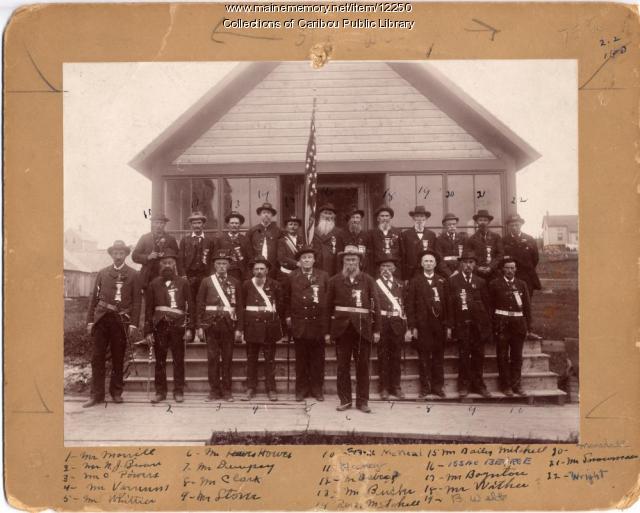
[130,61,540,176]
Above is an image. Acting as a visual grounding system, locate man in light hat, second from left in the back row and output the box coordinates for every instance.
[178,212,214,314]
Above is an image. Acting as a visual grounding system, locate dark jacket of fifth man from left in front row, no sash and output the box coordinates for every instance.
[284,269,329,339]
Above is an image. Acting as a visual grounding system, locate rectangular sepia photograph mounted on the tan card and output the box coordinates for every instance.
[63,59,580,447]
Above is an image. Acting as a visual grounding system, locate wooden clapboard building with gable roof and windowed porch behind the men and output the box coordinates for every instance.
[130,61,540,235]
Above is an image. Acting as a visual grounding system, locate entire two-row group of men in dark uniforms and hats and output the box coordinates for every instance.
[84,203,540,413]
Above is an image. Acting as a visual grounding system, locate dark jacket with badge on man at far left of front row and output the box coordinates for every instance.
[87,264,141,326]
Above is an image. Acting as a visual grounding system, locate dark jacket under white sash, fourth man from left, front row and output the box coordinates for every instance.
[242,278,285,344]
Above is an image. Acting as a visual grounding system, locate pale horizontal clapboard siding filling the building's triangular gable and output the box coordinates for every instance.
[175,62,495,165]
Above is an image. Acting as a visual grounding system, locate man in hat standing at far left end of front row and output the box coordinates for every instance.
[82,240,140,408]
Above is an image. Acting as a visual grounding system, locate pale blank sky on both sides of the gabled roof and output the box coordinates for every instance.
[63,60,578,248]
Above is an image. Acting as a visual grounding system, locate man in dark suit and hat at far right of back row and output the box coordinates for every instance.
[502,214,542,340]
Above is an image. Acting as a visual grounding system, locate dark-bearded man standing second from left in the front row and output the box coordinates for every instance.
[144,249,195,403]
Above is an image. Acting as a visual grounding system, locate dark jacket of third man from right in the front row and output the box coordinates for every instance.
[407,273,450,332]
